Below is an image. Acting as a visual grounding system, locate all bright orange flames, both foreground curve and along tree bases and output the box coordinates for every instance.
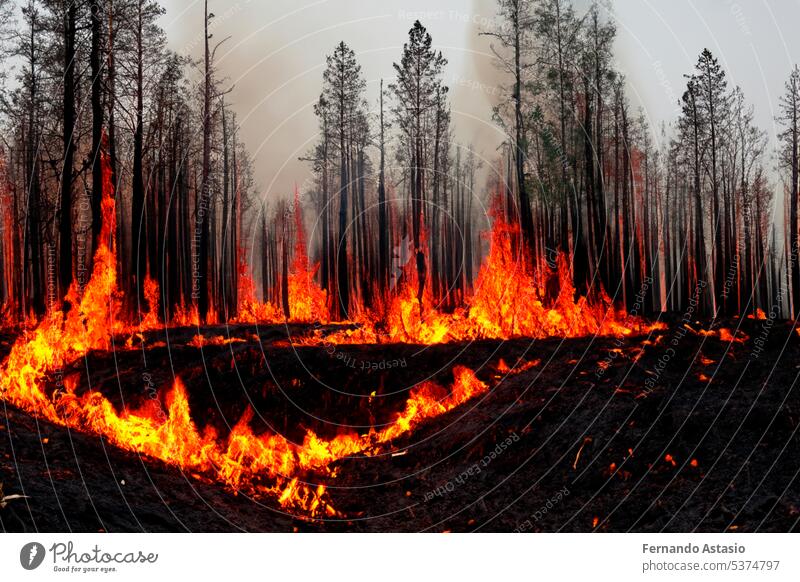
[1,153,664,517]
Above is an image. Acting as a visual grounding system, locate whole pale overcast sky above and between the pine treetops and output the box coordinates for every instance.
[162,0,800,202]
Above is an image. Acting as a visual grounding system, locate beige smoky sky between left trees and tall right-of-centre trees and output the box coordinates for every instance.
[162,0,503,210]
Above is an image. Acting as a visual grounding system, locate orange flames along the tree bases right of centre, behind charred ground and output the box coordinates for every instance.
[307,205,666,345]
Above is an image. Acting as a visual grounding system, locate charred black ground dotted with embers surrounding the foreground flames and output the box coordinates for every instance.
[0,318,800,532]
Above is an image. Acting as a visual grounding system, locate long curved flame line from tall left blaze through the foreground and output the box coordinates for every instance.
[0,146,488,517]
